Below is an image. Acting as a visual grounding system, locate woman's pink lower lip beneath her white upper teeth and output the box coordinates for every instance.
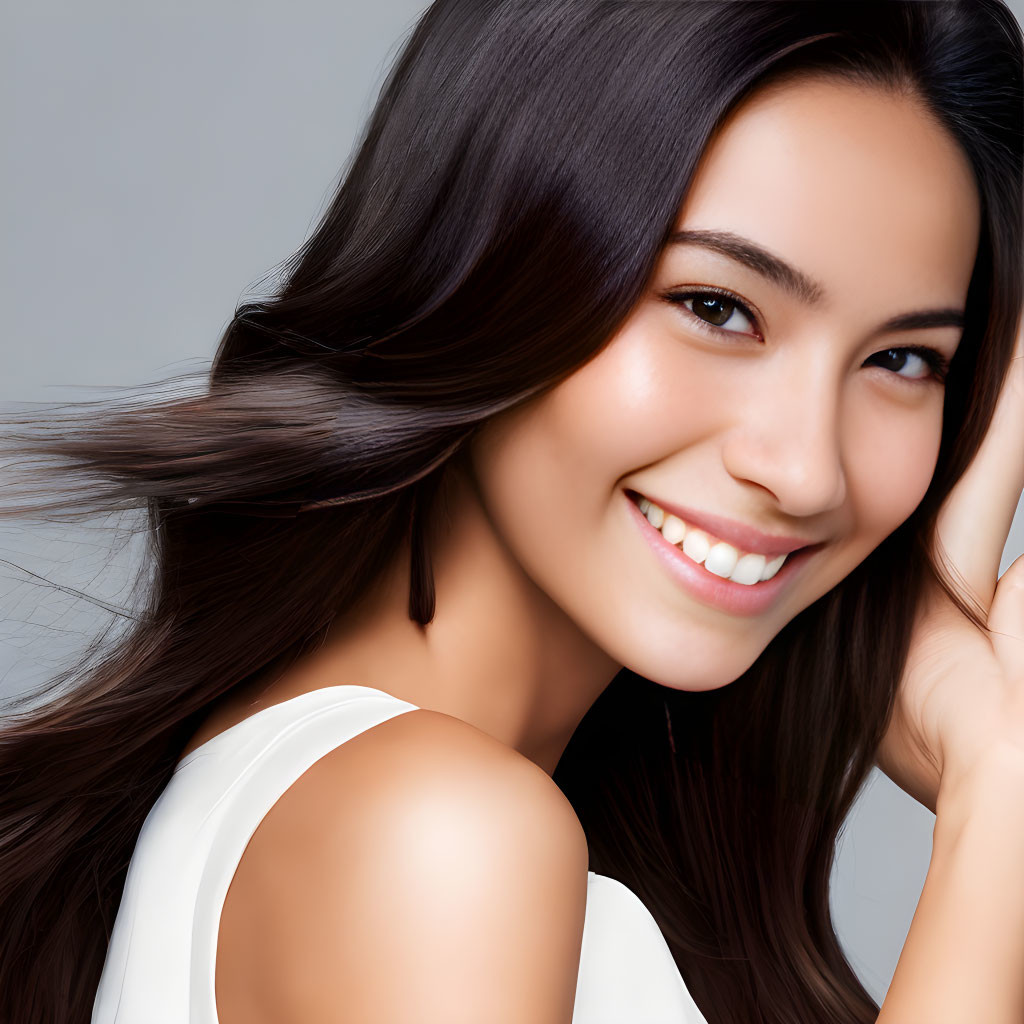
[624,492,821,615]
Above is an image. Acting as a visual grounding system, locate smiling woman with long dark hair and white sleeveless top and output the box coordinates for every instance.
[0,0,1024,1024]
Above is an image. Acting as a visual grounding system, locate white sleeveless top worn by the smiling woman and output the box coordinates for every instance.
[92,685,708,1024]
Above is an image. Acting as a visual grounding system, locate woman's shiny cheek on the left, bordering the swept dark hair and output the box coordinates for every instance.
[472,323,692,602]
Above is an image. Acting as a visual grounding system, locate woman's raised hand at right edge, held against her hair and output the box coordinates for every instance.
[878,305,1024,811]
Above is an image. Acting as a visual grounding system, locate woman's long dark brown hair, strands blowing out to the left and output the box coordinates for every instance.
[0,0,1024,1024]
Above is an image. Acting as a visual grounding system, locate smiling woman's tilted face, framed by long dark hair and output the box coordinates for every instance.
[472,79,980,689]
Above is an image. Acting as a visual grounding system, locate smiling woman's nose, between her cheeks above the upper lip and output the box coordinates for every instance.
[722,358,847,516]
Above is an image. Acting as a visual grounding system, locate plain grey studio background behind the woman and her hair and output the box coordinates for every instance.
[0,0,1024,1000]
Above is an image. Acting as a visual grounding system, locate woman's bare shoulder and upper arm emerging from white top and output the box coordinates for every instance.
[216,710,588,1024]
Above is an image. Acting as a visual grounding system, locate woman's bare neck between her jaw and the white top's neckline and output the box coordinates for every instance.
[315,475,621,774]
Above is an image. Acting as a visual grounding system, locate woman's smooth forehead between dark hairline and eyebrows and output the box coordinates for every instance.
[677,77,980,301]
